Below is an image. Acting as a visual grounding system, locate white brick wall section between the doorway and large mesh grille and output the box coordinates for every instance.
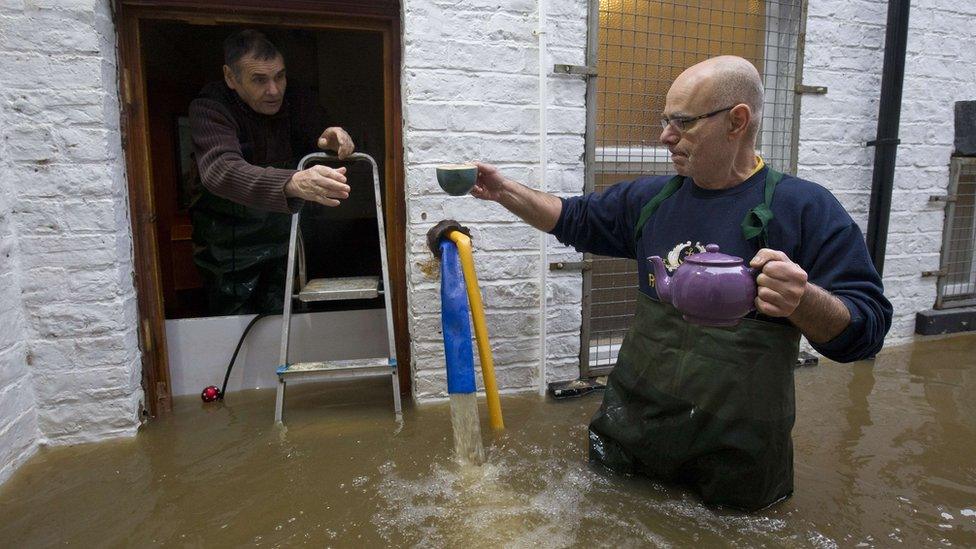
[403,0,586,400]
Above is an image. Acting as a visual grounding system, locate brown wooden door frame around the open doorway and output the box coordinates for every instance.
[113,0,411,416]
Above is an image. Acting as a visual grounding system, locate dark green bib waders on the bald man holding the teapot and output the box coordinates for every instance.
[589,170,800,511]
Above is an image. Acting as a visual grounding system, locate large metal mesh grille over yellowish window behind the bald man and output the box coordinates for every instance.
[580,0,805,376]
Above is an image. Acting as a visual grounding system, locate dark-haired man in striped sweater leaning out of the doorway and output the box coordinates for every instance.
[189,30,355,315]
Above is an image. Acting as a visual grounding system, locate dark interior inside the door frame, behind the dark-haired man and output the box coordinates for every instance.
[140,21,386,319]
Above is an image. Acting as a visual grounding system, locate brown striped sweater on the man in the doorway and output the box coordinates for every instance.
[190,82,329,213]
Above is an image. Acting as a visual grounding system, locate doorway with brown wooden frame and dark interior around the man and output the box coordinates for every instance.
[113,0,410,415]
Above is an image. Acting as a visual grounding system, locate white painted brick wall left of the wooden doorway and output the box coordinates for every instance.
[0,0,143,464]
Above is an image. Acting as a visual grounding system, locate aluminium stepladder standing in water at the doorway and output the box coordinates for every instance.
[275,153,402,423]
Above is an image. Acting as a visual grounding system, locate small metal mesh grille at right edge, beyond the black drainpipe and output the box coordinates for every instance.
[935,157,976,309]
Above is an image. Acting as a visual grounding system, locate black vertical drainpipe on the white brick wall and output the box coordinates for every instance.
[867,0,911,273]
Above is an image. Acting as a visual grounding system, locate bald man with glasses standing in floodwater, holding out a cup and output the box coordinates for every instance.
[471,56,892,510]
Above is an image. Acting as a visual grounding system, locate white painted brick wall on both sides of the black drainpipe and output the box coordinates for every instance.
[798,0,976,345]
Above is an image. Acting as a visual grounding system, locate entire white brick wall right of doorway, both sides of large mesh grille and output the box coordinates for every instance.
[404,0,976,398]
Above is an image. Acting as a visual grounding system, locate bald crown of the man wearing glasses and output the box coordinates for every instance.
[672,55,763,139]
